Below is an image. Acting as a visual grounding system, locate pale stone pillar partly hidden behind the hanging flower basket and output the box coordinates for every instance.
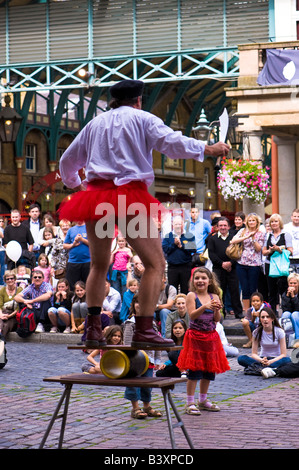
[243,132,265,221]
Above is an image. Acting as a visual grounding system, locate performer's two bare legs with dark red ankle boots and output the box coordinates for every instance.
[86,217,174,348]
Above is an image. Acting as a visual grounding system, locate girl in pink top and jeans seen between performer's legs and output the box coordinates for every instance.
[110,236,133,298]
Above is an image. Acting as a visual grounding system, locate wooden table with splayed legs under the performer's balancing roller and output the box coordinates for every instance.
[39,374,194,449]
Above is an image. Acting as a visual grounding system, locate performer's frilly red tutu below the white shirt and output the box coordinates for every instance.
[59,180,165,222]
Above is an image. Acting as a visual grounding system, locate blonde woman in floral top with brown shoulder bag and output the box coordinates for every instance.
[231,213,265,312]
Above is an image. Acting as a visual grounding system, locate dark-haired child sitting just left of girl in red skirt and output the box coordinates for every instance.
[156,320,187,377]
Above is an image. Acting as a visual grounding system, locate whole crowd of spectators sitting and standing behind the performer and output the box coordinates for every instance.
[0,204,299,356]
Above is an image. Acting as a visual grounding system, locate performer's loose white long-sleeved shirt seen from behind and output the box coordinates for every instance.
[59,106,205,188]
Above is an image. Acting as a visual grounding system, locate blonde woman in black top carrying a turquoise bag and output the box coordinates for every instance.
[262,214,293,316]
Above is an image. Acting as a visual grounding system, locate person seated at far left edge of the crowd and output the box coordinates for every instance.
[0,271,22,338]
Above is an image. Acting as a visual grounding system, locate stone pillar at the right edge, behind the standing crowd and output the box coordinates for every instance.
[274,137,297,223]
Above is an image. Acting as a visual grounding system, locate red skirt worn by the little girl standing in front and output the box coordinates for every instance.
[177,329,230,374]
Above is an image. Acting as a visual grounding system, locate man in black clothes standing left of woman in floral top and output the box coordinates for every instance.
[208,217,243,318]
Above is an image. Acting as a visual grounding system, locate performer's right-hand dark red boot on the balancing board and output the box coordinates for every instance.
[131,317,175,349]
